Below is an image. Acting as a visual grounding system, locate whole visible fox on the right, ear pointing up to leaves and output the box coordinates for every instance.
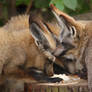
[51,5,92,92]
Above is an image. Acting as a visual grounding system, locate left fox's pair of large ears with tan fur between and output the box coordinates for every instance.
[29,13,56,49]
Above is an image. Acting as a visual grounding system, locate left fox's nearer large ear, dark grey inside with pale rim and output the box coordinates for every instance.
[29,15,49,49]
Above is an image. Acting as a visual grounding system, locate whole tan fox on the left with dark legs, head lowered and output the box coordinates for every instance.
[0,10,62,82]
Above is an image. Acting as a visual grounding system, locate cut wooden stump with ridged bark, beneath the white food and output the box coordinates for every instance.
[24,80,89,92]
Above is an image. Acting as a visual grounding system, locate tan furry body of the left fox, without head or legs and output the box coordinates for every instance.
[0,16,45,73]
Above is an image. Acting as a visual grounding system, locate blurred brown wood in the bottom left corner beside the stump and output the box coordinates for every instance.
[0,79,24,92]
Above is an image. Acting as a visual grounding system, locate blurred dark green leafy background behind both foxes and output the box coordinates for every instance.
[0,0,92,26]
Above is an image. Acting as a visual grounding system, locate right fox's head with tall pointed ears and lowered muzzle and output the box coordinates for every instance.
[51,5,85,73]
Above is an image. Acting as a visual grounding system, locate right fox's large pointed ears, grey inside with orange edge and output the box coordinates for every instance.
[52,7,80,54]
